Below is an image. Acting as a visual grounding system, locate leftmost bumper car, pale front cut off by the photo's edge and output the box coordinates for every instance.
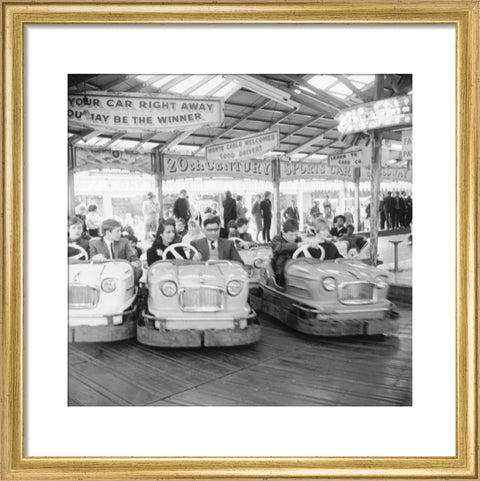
[68,258,138,342]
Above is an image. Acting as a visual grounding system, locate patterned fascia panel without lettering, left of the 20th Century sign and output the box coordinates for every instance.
[74,147,153,174]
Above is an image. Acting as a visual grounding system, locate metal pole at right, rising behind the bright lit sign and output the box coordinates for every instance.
[370,75,384,266]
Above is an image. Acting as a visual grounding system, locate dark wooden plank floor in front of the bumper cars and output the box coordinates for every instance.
[68,306,412,406]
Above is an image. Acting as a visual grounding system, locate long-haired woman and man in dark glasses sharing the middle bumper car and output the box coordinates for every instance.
[147,216,243,265]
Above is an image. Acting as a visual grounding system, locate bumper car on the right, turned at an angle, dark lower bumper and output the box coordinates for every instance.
[250,245,398,336]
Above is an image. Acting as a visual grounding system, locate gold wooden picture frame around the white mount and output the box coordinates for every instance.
[1,1,480,480]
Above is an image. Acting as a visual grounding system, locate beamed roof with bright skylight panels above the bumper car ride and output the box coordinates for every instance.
[68,74,412,161]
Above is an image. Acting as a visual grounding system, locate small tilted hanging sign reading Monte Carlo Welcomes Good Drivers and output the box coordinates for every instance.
[205,129,280,161]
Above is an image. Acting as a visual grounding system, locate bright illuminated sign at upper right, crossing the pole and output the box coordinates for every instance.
[335,95,413,134]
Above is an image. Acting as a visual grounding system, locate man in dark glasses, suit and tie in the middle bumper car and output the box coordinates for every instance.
[191,216,243,264]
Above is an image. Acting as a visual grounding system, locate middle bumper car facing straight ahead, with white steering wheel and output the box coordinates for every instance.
[137,244,260,347]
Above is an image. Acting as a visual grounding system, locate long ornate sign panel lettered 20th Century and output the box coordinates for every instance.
[162,154,273,181]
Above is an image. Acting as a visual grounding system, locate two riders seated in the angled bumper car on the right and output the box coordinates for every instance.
[272,218,343,286]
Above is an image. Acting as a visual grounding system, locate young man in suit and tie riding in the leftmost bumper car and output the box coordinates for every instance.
[90,219,142,282]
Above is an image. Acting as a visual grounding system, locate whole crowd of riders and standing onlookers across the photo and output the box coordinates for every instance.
[68,189,412,285]
